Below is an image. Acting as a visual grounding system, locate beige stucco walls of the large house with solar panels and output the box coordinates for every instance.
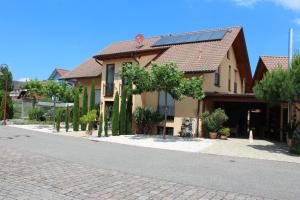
[96,47,244,135]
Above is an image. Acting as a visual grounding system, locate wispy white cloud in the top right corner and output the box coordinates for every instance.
[230,0,300,12]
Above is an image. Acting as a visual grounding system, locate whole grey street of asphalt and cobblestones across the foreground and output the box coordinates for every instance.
[0,128,300,199]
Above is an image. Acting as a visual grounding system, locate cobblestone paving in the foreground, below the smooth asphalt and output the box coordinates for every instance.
[0,148,274,200]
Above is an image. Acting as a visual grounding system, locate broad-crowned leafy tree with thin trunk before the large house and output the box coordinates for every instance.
[121,63,204,138]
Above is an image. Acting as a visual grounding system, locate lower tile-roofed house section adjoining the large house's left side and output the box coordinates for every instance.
[61,58,102,104]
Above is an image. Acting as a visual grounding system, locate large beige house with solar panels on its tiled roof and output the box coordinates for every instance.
[94,27,253,136]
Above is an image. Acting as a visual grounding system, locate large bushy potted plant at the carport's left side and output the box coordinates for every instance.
[201,108,228,139]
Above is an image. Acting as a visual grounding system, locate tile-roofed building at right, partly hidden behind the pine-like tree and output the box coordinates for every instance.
[253,56,288,141]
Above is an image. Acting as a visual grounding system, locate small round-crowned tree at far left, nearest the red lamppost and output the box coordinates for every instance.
[22,80,44,108]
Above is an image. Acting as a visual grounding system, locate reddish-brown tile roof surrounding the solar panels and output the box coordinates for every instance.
[95,27,242,72]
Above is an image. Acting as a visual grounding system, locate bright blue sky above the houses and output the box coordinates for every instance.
[0,0,300,80]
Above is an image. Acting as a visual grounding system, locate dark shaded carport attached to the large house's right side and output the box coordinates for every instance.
[203,93,287,141]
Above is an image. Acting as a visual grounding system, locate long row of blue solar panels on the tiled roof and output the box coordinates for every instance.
[152,30,227,47]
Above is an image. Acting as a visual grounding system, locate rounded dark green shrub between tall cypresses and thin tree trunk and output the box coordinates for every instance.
[133,107,163,134]
